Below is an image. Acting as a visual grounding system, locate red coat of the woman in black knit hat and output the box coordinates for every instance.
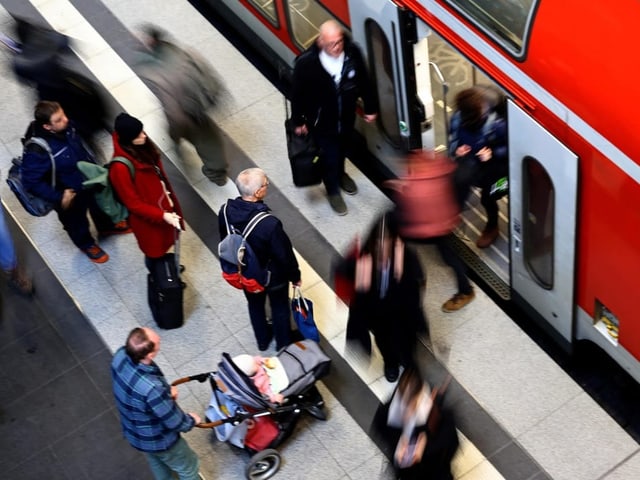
[109,134,184,258]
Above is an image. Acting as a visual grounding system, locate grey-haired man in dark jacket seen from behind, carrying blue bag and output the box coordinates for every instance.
[218,168,302,351]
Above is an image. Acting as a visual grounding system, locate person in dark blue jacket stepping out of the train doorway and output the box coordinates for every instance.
[449,86,508,248]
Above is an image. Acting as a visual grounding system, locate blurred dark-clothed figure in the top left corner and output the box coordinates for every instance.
[13,19,107,152]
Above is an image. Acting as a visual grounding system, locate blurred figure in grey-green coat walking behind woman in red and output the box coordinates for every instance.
[137,26,228,186]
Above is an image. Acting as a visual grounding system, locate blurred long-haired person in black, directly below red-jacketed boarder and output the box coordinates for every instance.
[338,214,428,382]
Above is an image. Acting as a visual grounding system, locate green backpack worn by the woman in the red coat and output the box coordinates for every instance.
[78,157,135,224]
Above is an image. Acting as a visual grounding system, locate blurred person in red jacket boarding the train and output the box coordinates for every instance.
[385,150,475,313]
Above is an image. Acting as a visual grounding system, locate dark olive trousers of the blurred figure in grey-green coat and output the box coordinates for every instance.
[169,115,229,180]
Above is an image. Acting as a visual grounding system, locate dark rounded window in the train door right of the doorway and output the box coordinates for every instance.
[523,157,555,290]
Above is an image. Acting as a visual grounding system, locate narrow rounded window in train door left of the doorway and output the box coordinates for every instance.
[365,20,401,148]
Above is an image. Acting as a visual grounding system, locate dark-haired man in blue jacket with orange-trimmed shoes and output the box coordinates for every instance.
[22,101,131,263]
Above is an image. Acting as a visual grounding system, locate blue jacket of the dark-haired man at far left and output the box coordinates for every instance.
[22,122,95,205]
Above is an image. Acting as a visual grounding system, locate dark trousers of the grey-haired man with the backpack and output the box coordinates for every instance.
[244,283,291,350]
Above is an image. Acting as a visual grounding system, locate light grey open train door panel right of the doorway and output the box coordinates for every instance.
[507,101,578,345]
